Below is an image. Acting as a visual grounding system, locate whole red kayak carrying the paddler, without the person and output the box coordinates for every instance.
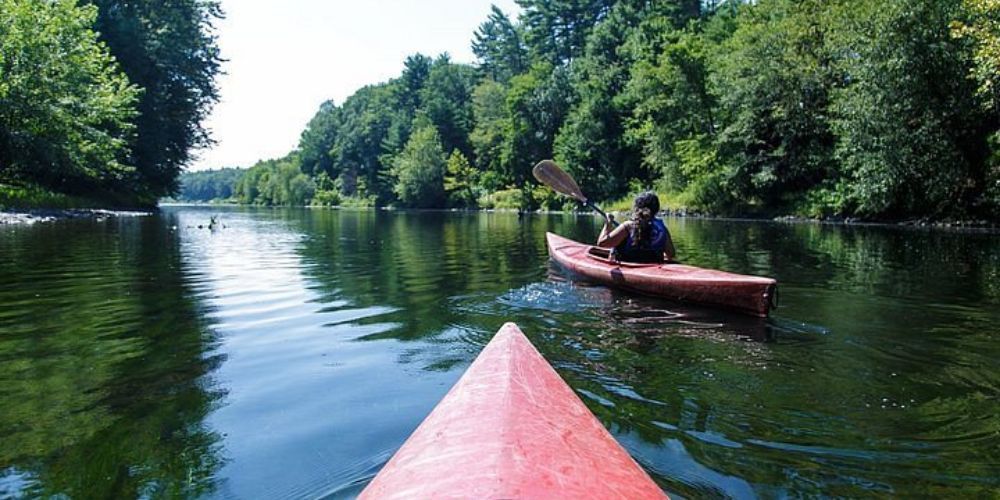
[545,233,777,317]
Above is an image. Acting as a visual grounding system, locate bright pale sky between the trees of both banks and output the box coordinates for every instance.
[188,0,520,170]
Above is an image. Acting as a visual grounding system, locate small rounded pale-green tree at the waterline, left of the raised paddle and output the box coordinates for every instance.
[391,119,445,208]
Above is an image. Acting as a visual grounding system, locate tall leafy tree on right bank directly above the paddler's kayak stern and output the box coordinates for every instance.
[712,0,839,210]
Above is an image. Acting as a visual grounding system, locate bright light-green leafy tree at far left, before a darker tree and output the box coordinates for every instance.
[0,0,139,199]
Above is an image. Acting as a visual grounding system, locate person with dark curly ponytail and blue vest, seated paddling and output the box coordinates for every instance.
[597,191,675,263]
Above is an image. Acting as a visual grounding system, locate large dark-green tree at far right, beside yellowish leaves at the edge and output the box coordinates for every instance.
[833,0,990,217]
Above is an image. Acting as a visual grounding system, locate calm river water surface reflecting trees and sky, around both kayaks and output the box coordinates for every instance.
[0,207,1000,498]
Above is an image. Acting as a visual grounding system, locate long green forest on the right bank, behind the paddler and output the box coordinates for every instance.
[197,0,1000,218]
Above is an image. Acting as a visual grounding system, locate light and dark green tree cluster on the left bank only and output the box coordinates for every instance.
[0,0,221,205]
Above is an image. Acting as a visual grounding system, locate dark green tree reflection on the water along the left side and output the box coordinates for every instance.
[0,217,225,498]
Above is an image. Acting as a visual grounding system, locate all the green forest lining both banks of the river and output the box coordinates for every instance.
[7,0,1000,220]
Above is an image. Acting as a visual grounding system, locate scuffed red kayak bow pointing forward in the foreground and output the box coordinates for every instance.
[361,323,666,498]
